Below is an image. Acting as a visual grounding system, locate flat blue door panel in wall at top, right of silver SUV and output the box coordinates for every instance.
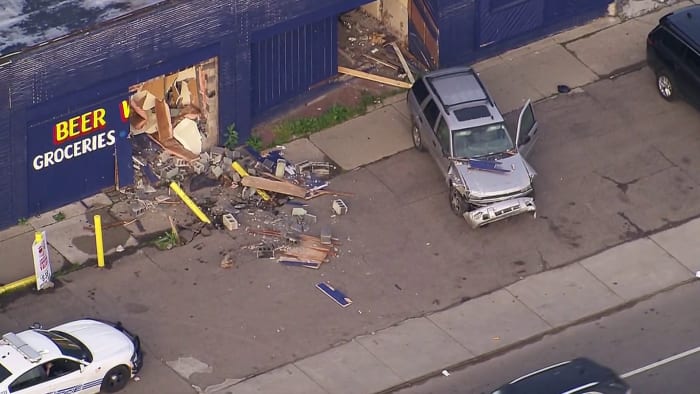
[477,0,545,48]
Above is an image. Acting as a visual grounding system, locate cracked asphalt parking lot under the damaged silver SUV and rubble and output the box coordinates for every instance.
[0,68,700,393]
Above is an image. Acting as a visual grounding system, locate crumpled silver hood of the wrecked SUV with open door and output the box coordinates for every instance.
[455,153,534,198]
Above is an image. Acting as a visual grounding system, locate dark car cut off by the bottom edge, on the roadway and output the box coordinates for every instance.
[493,358,632,394]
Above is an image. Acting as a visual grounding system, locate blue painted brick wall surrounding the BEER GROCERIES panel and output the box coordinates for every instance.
[0,0,369,227]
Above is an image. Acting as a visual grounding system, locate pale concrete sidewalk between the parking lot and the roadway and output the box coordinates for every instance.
[227,219,700,394]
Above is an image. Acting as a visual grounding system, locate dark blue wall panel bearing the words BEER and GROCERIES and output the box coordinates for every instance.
[27,98,134,215]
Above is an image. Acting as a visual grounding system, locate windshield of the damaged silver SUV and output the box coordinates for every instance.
[452,123,513,159]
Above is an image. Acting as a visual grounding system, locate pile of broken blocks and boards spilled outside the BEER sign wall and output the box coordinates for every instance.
[119,141,352,269]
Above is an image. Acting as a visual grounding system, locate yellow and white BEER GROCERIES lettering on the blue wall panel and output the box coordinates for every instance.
[32,100,130,171]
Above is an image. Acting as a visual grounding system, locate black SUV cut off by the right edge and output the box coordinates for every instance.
[647,5,700,103]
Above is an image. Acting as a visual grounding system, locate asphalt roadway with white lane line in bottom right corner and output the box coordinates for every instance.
[398,282,700,394]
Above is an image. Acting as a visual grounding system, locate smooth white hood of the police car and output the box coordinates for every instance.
[51,320,134,360]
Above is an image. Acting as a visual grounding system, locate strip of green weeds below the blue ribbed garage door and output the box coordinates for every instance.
[271,92,395,145]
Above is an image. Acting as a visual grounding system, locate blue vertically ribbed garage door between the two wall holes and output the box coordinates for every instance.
[251,15,338,116]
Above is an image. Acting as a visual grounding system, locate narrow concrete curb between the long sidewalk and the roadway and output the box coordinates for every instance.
[374,277,700,394]
